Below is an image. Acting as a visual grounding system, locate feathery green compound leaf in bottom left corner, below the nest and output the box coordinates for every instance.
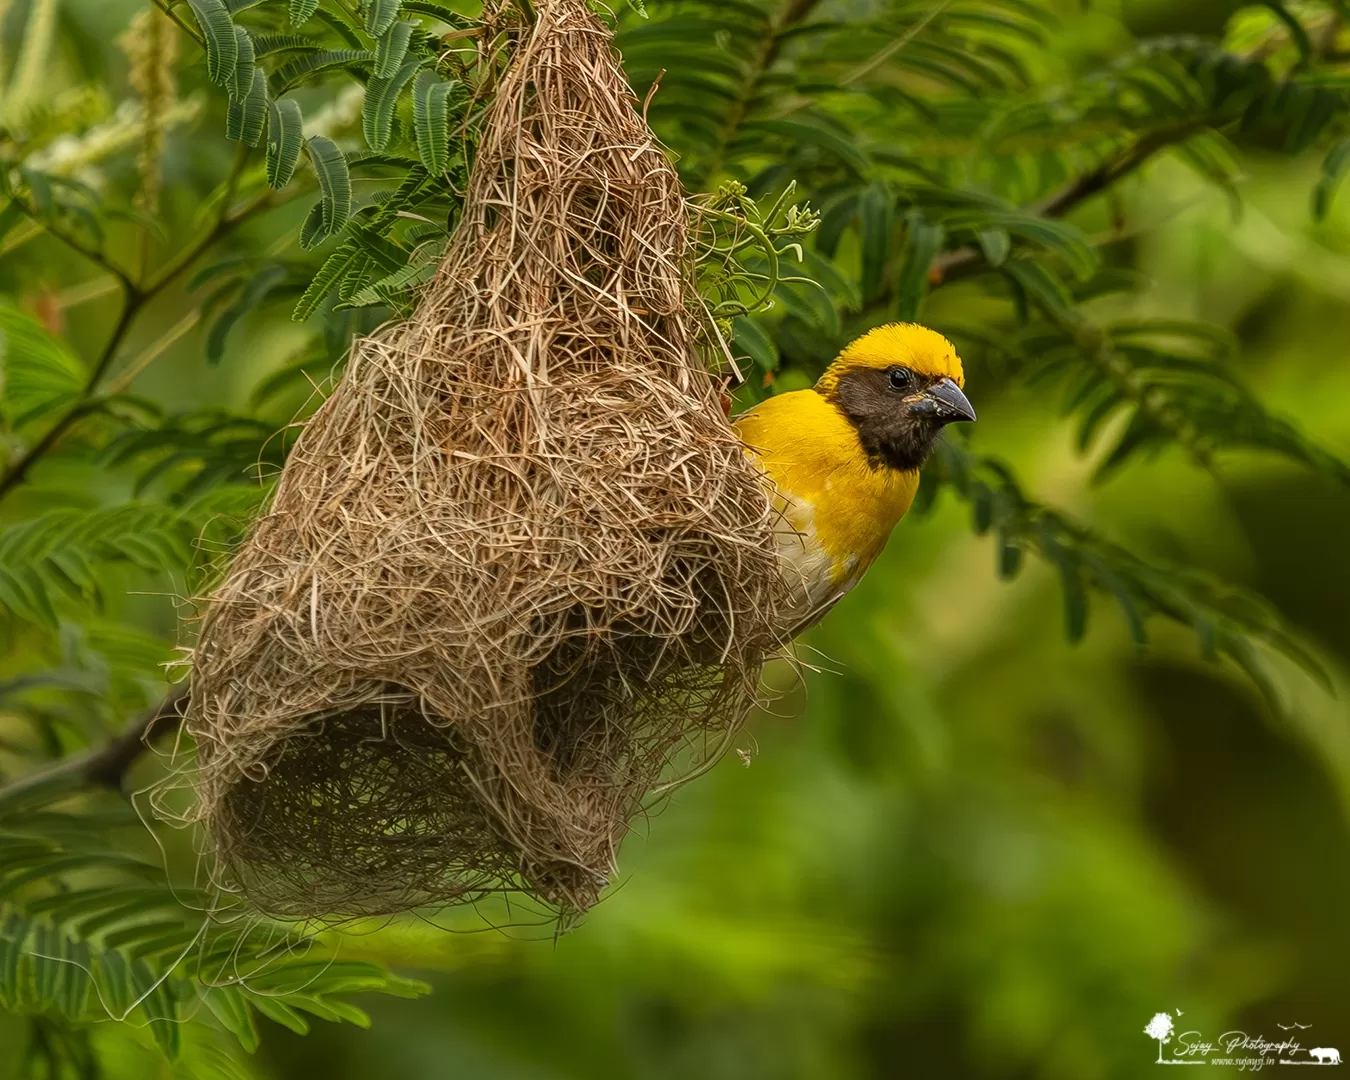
[0,815,429,1053]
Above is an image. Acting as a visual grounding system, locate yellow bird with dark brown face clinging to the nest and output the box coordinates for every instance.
[734,323,975,640]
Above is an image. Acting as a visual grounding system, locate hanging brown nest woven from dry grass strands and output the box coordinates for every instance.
[186,0,783,918]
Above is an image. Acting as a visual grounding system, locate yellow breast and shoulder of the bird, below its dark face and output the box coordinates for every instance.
[736,390,919,587]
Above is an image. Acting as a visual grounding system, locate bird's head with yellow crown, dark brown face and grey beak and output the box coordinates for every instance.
[815,323,975,471]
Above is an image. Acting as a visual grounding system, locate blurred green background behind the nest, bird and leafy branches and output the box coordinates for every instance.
[0,0,1350,1080]
